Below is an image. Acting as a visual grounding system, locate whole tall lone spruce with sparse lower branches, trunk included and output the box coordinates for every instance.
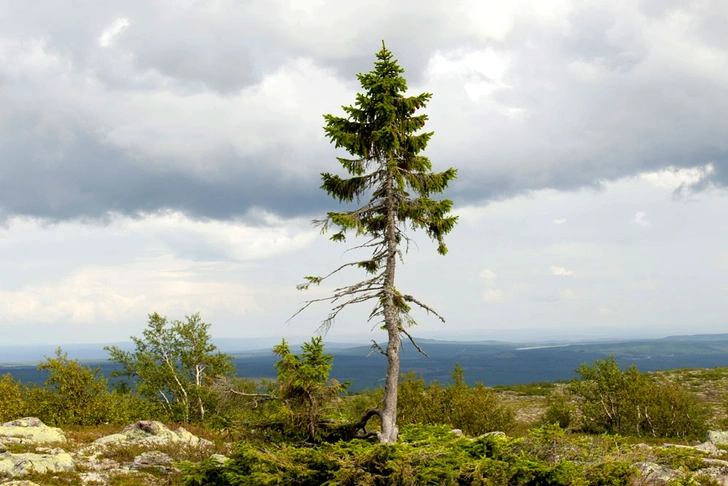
[298,42,457,442]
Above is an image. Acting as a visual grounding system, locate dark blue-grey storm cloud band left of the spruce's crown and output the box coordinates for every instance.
[0,114,327,219]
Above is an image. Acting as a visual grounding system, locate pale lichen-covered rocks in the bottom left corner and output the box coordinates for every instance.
[0,417,226,486]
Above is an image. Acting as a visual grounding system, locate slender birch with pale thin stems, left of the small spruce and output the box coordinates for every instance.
[105,313,235,423]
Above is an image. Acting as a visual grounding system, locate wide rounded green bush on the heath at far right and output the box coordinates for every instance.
[570,355,707,437]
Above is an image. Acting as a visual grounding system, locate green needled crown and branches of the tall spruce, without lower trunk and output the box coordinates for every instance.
[299,42,457,325]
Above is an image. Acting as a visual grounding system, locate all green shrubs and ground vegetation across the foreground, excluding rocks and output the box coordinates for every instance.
[0,315,728,486]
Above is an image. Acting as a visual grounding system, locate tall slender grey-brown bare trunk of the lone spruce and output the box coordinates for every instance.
[379,174,400,443]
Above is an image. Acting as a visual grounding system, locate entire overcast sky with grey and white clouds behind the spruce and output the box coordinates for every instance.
[0,0,728,350]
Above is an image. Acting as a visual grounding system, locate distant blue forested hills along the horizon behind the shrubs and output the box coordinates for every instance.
[0,334,728,391]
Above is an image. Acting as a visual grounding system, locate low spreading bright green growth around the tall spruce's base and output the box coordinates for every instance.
[183,426,636,486]
